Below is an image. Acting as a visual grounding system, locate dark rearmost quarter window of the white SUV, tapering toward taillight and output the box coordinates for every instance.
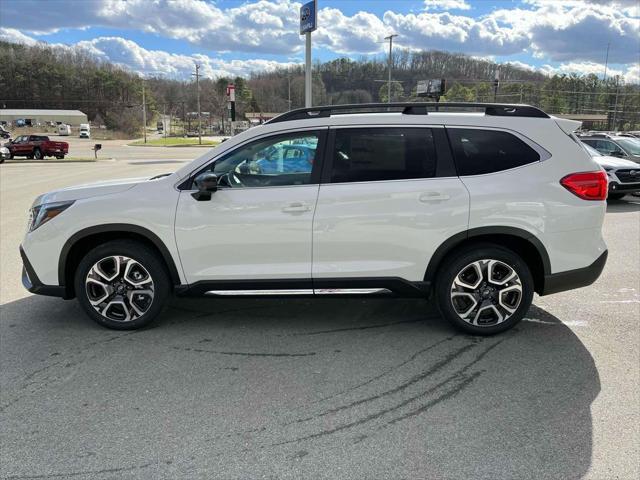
[447,128,540,176]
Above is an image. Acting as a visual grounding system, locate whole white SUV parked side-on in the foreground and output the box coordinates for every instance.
[21,103,607,334]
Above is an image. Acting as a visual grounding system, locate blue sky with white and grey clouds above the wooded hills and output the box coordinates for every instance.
[0,0,640,83]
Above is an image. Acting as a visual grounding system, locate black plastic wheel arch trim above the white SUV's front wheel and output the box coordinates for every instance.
[58,223,181,298]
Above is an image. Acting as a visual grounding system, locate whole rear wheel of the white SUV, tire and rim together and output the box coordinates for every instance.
[436,244,534,335]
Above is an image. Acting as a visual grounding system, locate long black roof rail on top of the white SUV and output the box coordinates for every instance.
[265,102,549,123]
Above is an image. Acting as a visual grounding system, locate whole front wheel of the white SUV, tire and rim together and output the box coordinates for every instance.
[74,240,171,330]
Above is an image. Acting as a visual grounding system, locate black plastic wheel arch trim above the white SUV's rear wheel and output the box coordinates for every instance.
[424,227,551,293]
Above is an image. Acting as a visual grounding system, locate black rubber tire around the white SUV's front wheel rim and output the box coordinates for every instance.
[74,240,171,330]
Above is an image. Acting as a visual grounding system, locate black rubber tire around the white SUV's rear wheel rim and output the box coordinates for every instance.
[435,243,534,335]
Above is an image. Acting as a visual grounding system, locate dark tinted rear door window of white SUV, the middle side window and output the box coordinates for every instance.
[331,128,436,183]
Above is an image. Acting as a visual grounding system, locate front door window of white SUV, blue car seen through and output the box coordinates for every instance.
[209,132,319,188]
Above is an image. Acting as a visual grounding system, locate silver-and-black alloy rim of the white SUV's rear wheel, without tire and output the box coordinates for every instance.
[451,259,522,327]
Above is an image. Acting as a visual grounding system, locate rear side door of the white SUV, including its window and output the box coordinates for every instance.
[313,126,469,286]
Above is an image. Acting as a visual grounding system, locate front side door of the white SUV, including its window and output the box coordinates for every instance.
[175,128,327,293]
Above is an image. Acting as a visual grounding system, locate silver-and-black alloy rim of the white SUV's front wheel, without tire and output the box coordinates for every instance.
[85,255,154,322]
